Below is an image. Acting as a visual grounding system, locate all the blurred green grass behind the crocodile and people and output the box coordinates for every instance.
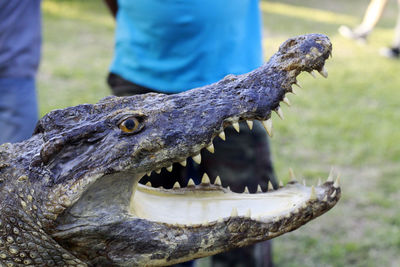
[38,0,400,266]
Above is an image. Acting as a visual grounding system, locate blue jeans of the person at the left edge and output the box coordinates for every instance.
[0,77,38,144]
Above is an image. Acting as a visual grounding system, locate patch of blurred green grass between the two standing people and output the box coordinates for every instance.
[38,1,114,115]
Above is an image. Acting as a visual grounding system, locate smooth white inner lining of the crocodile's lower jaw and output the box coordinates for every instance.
[129,173,340,226]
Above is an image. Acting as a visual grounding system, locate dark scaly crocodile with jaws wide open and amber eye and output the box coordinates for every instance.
[0,34,341,266]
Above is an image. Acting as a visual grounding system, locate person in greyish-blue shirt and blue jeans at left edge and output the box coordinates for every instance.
[0,0,41,144]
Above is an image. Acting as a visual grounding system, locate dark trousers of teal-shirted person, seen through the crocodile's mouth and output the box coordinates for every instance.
[107,73,278,267]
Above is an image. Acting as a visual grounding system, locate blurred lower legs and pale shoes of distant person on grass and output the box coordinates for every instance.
[339,0,400,58]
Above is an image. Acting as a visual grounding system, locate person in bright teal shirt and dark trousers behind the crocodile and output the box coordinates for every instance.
[105,0,278,267]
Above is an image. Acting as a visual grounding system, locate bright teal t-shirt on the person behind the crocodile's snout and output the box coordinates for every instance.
[110,0,262,93]
